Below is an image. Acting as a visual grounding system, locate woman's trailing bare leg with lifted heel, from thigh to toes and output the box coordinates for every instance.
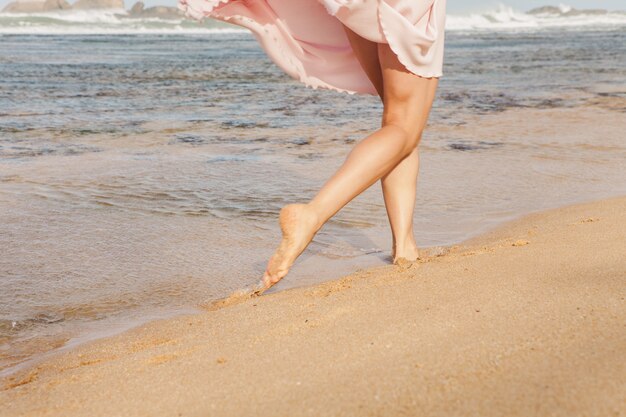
[263,44,437,287]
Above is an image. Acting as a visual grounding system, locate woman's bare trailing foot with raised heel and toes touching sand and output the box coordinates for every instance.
[263,204,319,289]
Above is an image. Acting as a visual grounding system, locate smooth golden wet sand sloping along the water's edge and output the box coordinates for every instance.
[0,197,626,417]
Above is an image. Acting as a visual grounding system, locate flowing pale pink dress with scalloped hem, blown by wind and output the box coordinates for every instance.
[178,0,446,94]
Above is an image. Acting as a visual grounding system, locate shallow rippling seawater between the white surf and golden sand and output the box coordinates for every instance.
[0,26,626,367]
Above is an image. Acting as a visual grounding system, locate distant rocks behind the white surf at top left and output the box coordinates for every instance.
[2,0,183,19]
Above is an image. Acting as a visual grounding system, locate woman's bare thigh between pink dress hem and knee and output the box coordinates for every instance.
[377,44,439,136]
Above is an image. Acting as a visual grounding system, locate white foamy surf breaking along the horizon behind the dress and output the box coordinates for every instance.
[0,5,626,35]
